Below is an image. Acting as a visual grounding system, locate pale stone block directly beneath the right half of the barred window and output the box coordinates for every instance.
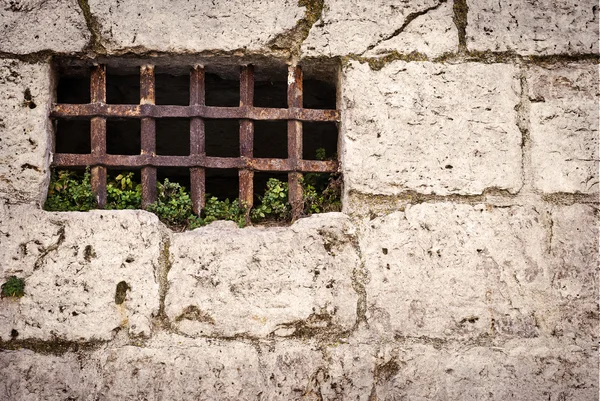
[165,213,360,336]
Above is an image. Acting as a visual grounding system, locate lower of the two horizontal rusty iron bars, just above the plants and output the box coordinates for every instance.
[52,153,338,173]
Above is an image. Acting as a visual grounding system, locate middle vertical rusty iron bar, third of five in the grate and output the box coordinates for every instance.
[190,65,206,215]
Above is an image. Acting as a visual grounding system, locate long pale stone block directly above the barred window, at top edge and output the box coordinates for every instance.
[89,0,304,52]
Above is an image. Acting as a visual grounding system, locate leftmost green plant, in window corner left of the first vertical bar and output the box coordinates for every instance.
[44,169,96,211]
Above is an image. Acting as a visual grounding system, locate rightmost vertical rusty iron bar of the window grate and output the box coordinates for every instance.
[287,65,304,221]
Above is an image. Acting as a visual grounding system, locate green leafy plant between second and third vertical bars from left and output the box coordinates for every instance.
[148,178,193,226]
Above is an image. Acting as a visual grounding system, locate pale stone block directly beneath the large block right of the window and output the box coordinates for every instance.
[361,204,556,339]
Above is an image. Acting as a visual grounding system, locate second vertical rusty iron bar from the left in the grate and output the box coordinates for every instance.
[140,65,156,209]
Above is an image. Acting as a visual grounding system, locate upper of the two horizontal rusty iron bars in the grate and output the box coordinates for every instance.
[50,103,340,122]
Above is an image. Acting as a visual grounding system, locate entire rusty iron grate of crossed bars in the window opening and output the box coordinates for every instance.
[51,65,339,219]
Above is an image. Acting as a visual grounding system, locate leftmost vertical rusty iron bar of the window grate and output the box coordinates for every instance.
[90,65,106,209]
